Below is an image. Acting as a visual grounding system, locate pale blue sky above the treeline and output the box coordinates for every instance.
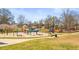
[9,8,79,22]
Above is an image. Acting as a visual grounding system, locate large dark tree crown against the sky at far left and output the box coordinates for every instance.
[0,8,14,24]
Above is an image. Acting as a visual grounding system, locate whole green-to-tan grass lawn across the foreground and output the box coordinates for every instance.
[0,33,79,50]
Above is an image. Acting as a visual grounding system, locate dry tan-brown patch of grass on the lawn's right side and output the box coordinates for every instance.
[58,33,79,45]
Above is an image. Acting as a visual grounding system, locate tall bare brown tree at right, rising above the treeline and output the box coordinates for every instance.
[63,9,77,30]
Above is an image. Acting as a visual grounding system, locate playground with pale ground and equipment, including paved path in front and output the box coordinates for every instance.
[0,24,57,47]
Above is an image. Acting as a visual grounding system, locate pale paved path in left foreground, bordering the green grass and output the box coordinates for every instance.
[0,39,32,47]
